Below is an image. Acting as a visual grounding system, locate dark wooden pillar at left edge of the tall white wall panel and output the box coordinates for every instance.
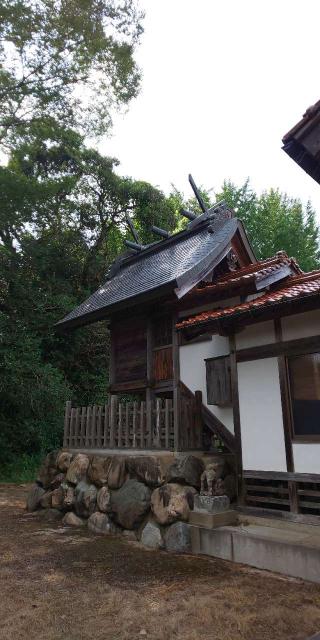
[229,335,244,503]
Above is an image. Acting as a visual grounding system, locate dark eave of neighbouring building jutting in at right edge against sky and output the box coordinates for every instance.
[282,100,320,184]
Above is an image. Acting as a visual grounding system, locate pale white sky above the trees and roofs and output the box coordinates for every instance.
[99,0,320,215]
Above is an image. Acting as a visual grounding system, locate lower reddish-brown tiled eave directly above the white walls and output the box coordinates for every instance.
[176,270,320,329]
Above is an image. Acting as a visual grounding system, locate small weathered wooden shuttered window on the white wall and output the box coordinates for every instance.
[206,356,232,407]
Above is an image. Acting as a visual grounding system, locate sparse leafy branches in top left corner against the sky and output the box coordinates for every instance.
[0,0,143,146]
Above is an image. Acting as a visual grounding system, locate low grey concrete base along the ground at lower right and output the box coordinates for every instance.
[191,523,320,583]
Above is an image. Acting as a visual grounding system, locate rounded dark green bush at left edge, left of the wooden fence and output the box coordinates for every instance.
[0,313,70,464]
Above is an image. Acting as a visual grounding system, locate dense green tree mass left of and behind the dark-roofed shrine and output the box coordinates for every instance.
[0,127,177,464]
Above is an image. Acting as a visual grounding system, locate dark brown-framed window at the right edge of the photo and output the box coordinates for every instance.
[288,353,320,439]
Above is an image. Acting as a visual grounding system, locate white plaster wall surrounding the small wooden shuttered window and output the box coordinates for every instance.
[179,336,234,433]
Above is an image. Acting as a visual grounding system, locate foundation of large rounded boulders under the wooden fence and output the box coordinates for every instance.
[27,449,234,552]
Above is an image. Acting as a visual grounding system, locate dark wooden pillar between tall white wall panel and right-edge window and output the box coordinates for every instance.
[274,318,299,513]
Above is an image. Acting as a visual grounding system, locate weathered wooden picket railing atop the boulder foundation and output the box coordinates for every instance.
[63,396,175,450]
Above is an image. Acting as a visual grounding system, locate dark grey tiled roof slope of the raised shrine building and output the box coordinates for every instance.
[58,218,243,326]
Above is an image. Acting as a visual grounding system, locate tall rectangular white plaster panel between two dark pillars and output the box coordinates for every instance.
[238,358,287,471]
